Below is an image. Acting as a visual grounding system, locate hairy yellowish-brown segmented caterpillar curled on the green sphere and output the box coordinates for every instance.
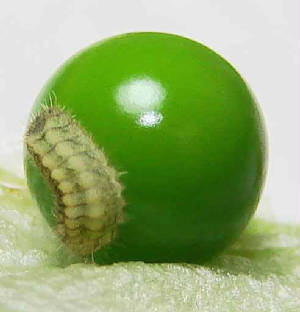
[25,106,125,255]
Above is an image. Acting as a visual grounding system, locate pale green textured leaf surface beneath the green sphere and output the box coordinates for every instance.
[0,170,299,312]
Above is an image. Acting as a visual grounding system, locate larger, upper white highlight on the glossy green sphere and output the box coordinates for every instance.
[116,76,166,114]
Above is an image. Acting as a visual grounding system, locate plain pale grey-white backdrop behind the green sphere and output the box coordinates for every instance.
[0,0,300,223]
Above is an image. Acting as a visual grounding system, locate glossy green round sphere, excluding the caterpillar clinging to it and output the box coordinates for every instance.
[25,33,266,263]
